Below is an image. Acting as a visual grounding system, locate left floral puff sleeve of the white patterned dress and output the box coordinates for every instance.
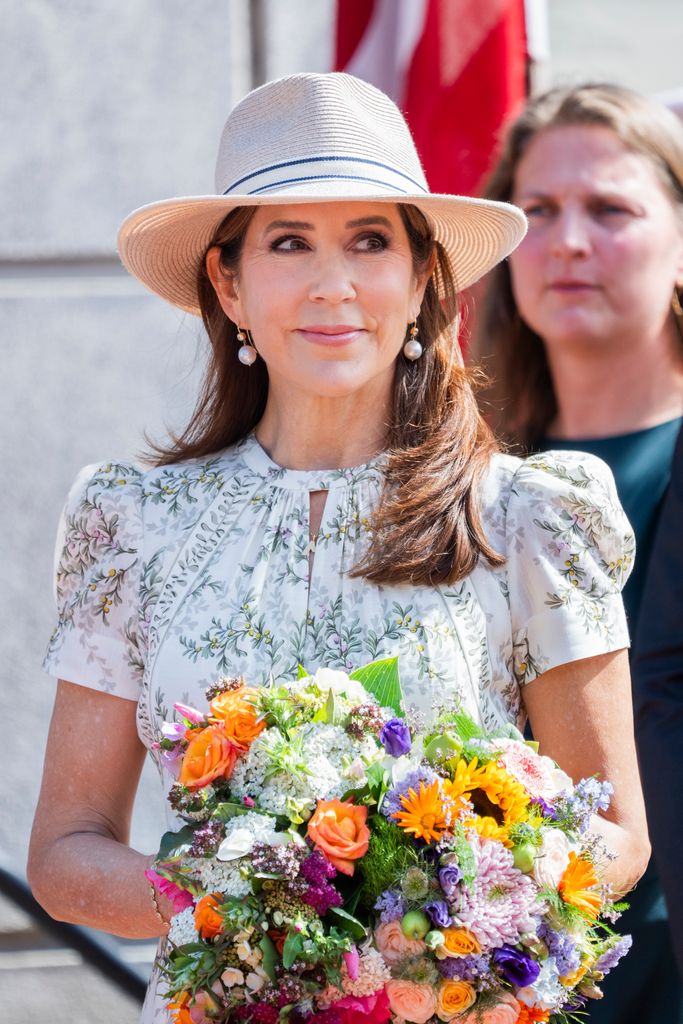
[43,463,144,700]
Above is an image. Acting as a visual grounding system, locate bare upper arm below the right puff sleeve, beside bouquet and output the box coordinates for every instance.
[523,650,646,834]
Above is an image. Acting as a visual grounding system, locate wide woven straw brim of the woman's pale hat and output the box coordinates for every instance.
[118,182,526,316]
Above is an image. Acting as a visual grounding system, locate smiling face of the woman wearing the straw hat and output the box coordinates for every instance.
[207,202,426,397]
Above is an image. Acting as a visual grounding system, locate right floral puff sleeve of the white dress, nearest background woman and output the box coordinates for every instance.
[506,452,635,685]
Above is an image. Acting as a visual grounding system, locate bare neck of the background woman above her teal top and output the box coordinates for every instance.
[547,329,683,440]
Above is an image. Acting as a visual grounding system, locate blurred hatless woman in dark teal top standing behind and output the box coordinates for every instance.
[474,85,683,1024]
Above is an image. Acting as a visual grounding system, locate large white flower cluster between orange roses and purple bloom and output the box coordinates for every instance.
[230,720,383,814]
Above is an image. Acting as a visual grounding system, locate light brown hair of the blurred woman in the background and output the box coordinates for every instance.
[472,83,683,451]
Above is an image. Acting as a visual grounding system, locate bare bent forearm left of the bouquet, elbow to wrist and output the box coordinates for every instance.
[29,831,172,939]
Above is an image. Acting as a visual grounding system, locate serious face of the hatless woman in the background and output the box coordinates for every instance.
[510,125,683,347]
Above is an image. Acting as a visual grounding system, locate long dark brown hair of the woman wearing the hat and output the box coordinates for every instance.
[152,204,503,585]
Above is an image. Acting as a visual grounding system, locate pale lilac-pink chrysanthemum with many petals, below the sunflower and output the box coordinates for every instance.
[453,835,543,949]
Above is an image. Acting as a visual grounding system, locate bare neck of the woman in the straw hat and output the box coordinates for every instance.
[256,385,390,469]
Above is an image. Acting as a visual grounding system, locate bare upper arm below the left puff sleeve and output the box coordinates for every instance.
[31,680,145,859]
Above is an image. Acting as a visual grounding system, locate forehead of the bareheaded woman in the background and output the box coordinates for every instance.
[514,125,665,198]
